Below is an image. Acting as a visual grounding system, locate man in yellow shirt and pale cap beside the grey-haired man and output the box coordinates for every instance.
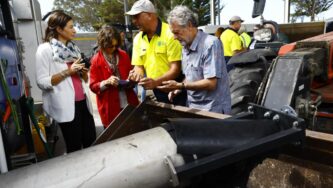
[126,0,186,106]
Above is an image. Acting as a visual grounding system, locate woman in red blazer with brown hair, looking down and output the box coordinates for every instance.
[89,26,139,128]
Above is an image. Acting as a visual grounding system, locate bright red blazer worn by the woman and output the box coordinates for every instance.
[89,49,139,128]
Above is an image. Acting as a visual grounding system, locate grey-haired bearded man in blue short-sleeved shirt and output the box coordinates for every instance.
[159,6,231,114]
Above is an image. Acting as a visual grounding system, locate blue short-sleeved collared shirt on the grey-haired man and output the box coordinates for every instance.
[182,30,231,114]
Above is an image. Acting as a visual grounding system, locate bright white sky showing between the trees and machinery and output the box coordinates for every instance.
[38,0,333,29]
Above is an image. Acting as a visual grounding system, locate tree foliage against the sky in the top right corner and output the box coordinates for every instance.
[290,0,333,21]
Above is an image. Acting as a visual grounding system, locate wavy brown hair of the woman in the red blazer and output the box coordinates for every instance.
[97,25,121,50]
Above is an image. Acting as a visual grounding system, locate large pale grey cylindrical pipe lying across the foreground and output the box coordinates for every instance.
[0,128,184,188]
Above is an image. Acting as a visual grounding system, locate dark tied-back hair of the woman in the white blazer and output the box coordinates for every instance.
[44,10,73,42]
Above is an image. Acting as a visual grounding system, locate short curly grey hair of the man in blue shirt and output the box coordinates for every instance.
[168,5,198,27]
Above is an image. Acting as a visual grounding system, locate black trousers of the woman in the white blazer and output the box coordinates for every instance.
[58,100,96,153]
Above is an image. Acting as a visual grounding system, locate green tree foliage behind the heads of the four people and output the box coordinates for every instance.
[54,0,223,31]
